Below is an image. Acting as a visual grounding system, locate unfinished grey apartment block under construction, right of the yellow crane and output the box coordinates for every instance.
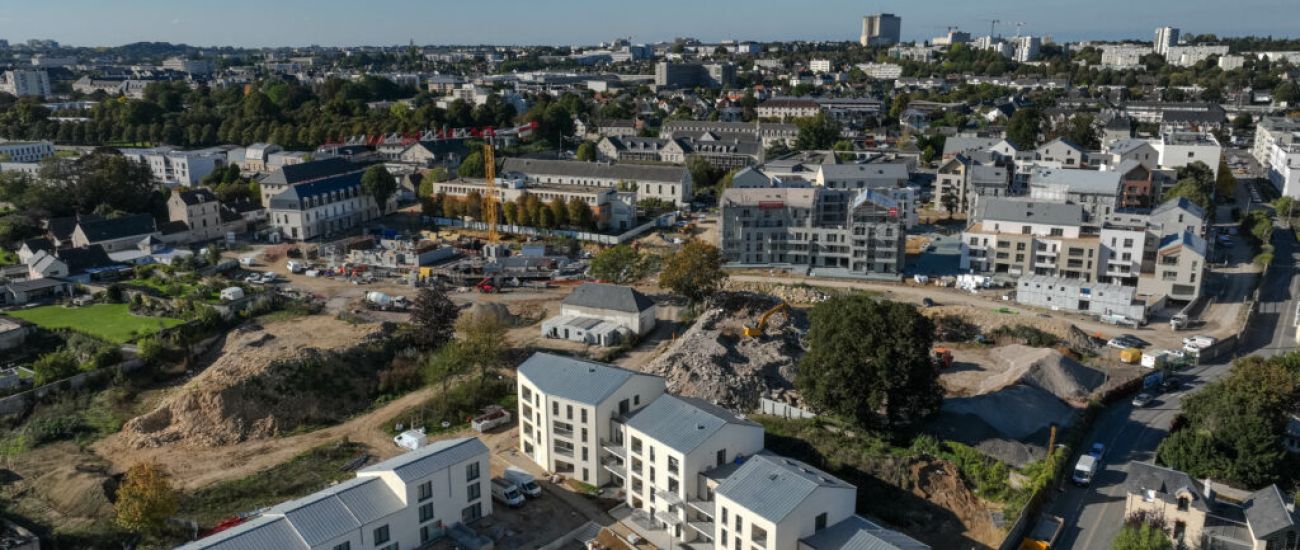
[719,186,906,278]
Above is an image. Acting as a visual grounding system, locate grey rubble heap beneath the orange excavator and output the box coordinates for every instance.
[644,293,809,411]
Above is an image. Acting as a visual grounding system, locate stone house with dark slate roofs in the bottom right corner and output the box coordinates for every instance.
[1125,462,1300,550]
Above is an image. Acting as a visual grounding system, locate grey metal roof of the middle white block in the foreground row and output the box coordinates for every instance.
[628,394,762,454]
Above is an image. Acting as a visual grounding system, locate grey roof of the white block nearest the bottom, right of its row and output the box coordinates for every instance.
[716,451,857,523]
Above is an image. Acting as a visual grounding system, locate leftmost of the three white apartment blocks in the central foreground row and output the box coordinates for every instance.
[517,352,666,486]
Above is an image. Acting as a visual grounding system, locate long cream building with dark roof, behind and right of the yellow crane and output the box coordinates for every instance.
[501,157,694,205]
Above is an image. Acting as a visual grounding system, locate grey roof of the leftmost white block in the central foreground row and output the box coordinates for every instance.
[519,352,657,404]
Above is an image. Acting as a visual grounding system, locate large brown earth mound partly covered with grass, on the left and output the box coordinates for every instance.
[122,316,376,449]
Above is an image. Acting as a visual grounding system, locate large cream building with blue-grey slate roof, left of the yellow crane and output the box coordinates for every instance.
[268,171,397,241]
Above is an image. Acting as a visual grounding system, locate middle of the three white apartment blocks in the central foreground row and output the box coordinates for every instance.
[618,394,763,542]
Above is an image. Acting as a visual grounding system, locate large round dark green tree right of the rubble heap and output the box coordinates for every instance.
[794,294,944,436]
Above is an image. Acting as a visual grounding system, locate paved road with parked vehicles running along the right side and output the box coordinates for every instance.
[1049,228,1300,550]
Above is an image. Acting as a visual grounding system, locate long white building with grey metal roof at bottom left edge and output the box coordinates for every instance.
[179,437,491,550]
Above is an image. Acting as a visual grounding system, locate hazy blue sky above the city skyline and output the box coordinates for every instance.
[0,0,1300,47]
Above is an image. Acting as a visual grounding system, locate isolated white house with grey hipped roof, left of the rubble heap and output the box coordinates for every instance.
[542,282,655,346]
